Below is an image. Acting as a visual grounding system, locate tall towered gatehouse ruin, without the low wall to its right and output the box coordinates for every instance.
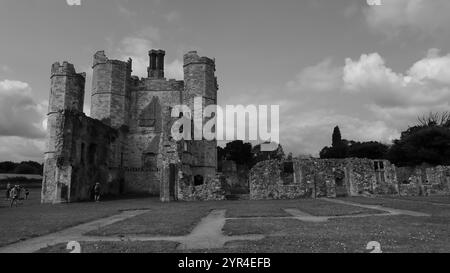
[42,50,223,203]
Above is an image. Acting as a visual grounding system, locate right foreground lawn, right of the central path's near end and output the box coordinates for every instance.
[221,197,450,253]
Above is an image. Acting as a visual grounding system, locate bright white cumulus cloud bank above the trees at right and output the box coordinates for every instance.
[272,49,450,155]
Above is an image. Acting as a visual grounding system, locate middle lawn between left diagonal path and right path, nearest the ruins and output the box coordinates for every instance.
[86,199,380,236]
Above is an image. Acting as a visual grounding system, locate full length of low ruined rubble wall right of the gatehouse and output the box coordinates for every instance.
[250,158,450,200]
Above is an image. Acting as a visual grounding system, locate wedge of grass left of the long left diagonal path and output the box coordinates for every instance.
[0,190,159,246]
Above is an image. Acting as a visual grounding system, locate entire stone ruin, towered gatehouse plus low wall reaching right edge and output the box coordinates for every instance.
[42,50,450,203]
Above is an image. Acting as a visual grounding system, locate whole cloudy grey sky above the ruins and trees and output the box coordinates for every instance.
[0,0,450,161]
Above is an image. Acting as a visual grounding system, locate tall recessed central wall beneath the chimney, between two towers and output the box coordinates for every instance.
[125,75,184,195]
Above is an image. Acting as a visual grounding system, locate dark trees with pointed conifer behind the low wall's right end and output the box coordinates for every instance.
[320,112,450,166]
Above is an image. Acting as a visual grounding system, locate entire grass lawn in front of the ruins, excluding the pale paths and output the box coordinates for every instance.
[0,192,450,253]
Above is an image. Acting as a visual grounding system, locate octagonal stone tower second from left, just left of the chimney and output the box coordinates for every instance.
[91,51,132,128]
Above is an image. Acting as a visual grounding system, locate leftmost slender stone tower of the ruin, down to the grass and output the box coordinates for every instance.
[42,62,86,203]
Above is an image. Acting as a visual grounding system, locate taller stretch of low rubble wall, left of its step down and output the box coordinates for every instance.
[250,158,398,199]
